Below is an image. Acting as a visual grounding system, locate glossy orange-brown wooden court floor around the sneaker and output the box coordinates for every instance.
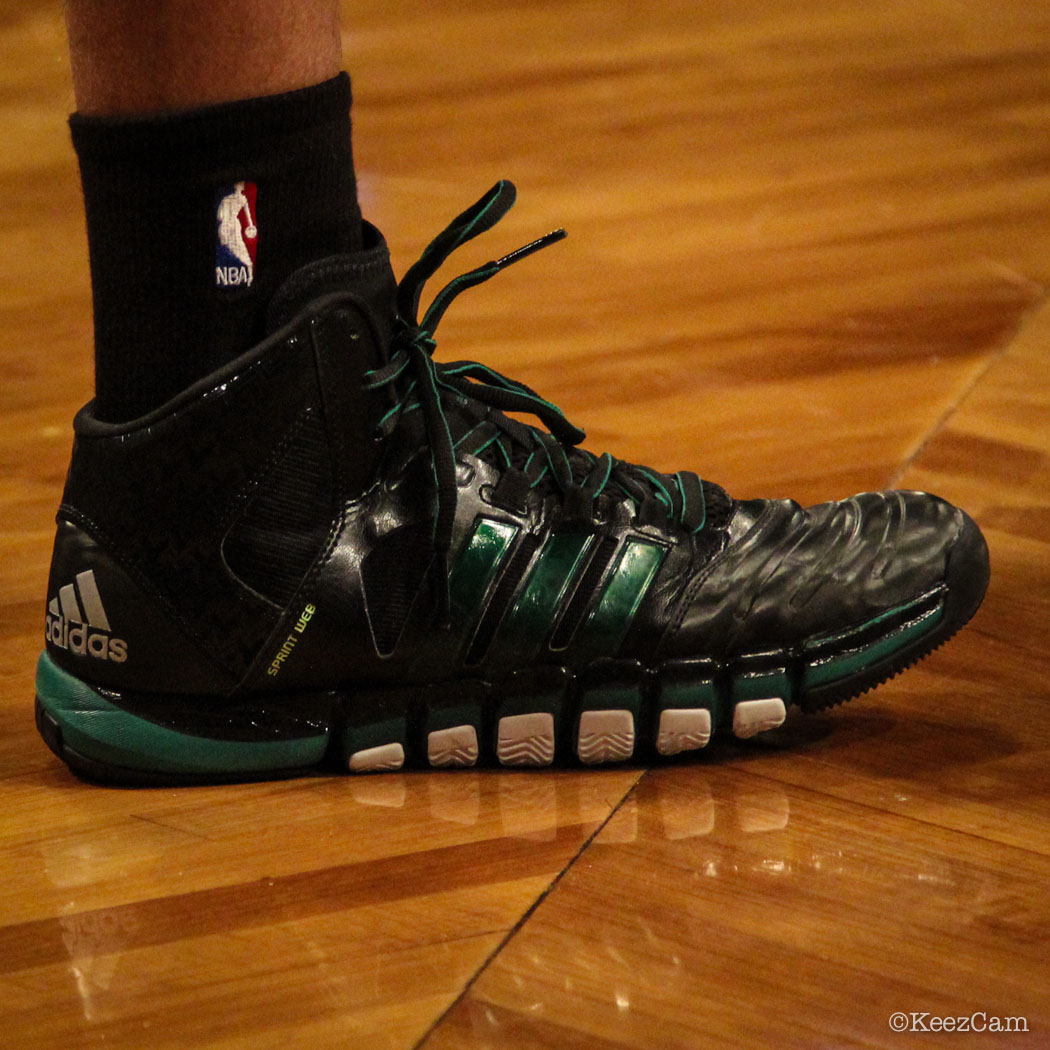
[0,0,1050,1050]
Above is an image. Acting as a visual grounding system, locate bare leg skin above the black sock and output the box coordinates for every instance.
[66,0,342,116]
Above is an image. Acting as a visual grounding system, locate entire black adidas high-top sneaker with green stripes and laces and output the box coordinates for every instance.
[37,183,988,782]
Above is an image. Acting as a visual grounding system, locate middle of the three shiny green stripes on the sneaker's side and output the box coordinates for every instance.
[491,532,593,669]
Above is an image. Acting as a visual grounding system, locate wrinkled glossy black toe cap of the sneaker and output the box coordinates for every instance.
[667,491,974,657]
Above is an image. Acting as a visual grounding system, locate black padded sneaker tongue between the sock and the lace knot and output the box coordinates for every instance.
[267,223,397,353]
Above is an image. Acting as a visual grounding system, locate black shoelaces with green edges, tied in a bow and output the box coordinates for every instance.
[364,180,707,627]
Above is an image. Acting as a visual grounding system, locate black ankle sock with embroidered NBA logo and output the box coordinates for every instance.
[69,74,361,422]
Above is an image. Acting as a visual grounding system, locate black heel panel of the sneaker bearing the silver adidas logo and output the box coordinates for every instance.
[44,519,235,693]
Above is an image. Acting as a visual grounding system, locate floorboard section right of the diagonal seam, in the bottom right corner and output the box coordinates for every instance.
[424,763,1050,1050]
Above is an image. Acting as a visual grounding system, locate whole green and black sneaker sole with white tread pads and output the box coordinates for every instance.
[37,567,983,785]
